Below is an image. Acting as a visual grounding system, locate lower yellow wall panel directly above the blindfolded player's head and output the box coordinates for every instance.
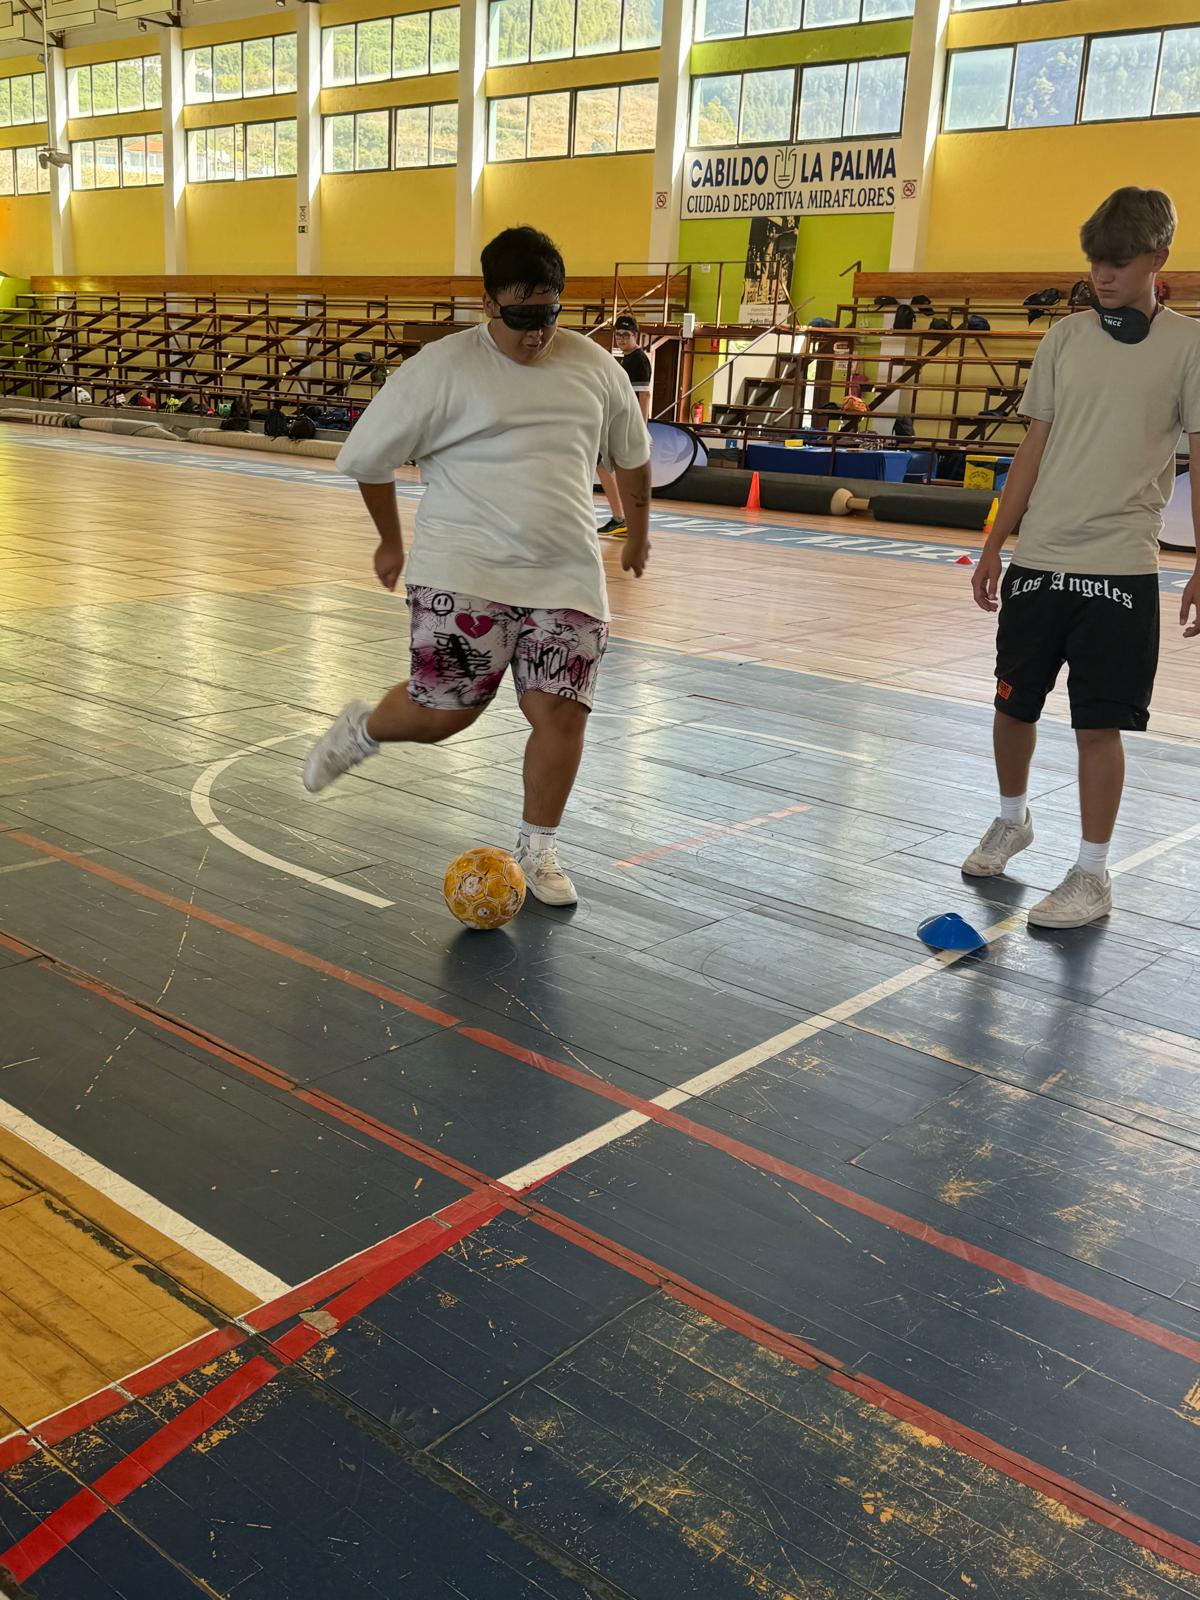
[483,154,654,274]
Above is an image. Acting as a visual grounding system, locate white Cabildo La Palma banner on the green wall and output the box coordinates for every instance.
[683,139,899,221]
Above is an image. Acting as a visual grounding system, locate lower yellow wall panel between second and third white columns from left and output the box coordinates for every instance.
[184,178,296,274]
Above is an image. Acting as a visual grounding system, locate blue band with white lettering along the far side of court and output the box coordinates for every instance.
[2,430,1189,592]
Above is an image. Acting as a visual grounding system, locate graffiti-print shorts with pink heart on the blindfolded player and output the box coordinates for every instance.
[408,586,608,710]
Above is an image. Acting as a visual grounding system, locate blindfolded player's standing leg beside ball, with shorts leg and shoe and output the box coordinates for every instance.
[512,611,608,906]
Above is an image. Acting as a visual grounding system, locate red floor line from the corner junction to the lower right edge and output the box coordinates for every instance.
[528,1202,1200,1573]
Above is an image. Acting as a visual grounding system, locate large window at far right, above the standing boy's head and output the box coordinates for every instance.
[942,27,1200,133]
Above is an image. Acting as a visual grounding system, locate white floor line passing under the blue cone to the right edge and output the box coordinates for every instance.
[499,822,1200,1189]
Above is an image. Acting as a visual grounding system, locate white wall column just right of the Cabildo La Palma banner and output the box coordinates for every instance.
[888,0,950,272]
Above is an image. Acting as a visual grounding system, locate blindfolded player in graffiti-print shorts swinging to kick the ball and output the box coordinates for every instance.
[304,227,650,906]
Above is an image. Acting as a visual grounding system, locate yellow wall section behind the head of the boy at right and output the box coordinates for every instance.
[923,117,1200,272]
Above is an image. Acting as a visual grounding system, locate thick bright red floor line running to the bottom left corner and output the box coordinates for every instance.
[0,1194,504,1582]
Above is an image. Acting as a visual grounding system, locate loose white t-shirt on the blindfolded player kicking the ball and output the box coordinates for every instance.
[338,323,650,621]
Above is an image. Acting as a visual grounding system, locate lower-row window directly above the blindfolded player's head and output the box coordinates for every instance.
[488,83,658,162]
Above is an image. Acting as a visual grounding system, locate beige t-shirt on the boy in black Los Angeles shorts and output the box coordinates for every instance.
[1013,309,1200,578]
